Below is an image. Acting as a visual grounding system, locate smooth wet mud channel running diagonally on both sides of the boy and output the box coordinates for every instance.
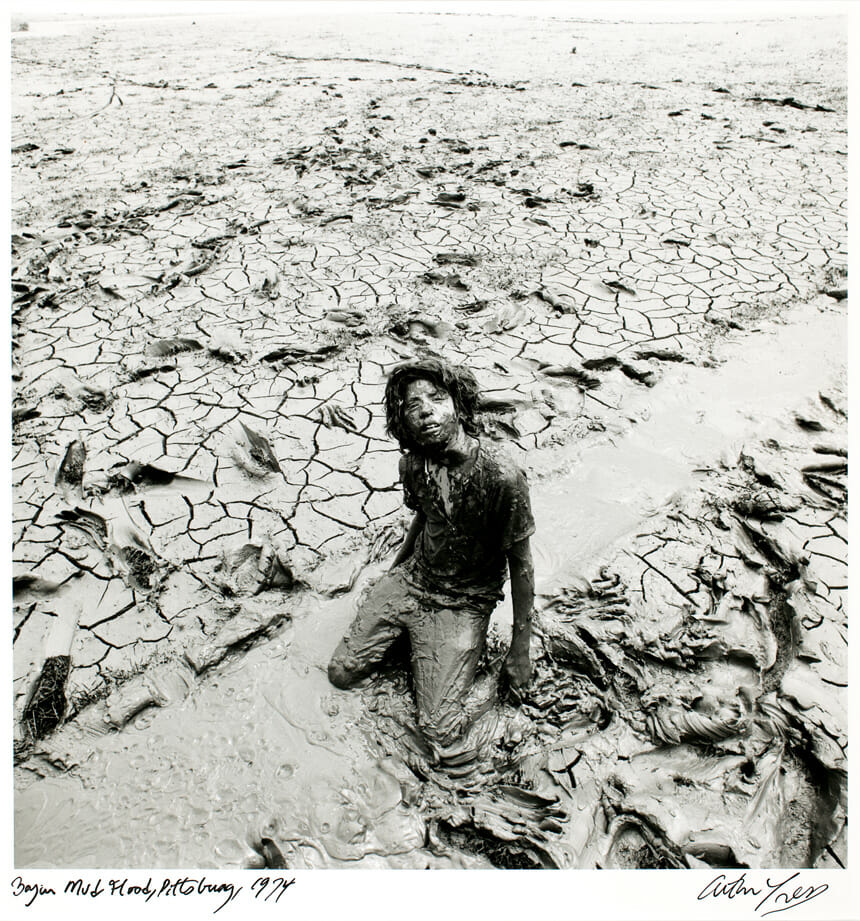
[15,305,846,868]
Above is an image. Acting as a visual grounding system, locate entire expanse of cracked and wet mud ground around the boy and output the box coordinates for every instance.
[12,7,847,868]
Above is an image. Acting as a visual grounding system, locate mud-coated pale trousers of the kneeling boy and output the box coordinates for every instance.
[329,569,492,750]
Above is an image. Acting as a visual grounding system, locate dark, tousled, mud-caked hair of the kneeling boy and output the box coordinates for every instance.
[385,358,479,451]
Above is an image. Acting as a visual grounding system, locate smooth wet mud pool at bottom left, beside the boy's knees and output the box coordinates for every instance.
[15,580,436,868]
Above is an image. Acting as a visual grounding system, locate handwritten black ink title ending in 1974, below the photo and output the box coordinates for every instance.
[12,876,296,914]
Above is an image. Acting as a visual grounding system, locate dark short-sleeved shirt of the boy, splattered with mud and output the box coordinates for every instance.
[400,440,535,607]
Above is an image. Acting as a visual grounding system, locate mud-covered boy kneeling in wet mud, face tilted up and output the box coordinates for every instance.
[328,359,534,760]
